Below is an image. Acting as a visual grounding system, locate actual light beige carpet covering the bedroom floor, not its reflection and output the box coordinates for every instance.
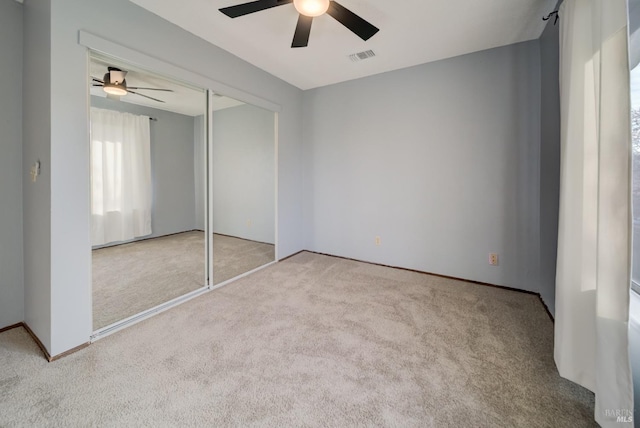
[0,253,596,427]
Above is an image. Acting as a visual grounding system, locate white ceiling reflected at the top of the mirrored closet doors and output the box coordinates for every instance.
[89,54,244,116]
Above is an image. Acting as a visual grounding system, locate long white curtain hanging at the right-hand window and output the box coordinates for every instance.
[554,0,633,427]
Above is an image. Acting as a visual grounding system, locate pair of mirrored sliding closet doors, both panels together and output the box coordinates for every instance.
[88,52,277,337]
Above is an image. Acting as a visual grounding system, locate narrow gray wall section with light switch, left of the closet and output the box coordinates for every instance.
[22,0,52,349]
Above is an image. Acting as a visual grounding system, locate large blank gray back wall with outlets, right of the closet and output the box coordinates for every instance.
[304,41,540,291]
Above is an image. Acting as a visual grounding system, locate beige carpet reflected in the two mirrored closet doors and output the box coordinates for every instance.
[92,231,274,330]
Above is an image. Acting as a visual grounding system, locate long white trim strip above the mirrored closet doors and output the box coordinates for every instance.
[78,30,282,112]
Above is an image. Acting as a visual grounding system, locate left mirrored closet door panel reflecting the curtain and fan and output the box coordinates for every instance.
[89,54,208,331]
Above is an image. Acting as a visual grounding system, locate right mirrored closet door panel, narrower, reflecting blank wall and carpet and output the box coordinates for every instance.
[210,94,276,284]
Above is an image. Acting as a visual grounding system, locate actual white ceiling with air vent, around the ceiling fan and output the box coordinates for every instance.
[130,0,557,89]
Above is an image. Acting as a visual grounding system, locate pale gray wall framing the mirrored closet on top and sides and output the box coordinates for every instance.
[25,0,303,355]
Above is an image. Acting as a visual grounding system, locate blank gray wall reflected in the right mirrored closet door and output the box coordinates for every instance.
[212,104,275,244]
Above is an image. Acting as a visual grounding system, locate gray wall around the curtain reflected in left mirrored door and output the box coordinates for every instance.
[91,96,195,244]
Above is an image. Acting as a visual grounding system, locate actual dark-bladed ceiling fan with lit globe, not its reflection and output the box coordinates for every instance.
[219,0,379,48]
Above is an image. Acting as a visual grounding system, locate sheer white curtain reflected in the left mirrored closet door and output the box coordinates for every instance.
[91,107,151,245]
